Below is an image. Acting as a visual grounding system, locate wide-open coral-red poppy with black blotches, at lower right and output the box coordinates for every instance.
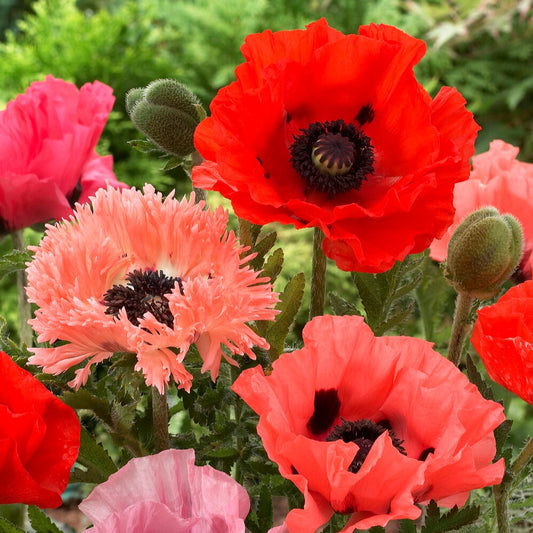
[233,316,505,533]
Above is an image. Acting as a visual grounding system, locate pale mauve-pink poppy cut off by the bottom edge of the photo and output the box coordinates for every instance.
[79,450,250,533]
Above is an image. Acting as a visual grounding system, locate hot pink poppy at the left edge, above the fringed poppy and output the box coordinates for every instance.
[0,76,126,231]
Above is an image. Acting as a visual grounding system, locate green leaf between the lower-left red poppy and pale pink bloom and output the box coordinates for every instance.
[70,427,117,483]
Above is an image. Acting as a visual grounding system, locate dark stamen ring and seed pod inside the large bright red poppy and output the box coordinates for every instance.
[289,120,374,197]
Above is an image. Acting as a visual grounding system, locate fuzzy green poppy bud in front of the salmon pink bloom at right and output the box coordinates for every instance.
[445,207,522,300]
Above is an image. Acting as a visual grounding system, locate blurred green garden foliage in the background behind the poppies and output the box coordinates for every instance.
[0,0,533,434]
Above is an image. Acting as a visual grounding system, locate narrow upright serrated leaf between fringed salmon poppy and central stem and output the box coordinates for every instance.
[266,272,305,361]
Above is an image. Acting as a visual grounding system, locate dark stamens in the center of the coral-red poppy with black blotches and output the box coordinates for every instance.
[326,419,407,474]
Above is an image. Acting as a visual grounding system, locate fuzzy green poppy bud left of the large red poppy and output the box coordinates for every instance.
[126,79,201,157]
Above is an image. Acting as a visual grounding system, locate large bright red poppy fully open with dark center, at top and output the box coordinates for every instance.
[193,19,478,272]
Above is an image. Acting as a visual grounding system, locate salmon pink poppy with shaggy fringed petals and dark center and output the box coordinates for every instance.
[27,185,277,393]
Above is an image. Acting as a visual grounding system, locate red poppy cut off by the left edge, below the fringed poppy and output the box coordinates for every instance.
[0,352,80,507]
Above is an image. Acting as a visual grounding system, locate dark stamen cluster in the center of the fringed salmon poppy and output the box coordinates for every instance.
[104,270,184,328]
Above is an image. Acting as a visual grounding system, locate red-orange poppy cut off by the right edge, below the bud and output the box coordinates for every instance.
[471,281,533,405]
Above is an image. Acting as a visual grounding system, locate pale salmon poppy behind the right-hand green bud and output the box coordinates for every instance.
[431,140,533,281]
